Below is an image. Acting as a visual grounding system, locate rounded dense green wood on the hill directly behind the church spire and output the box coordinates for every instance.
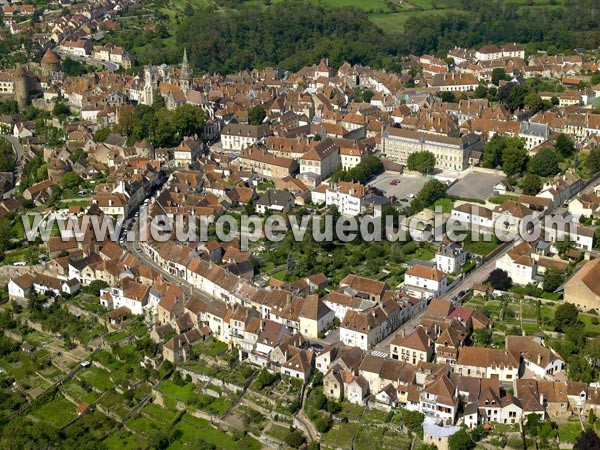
[176,1,398,73]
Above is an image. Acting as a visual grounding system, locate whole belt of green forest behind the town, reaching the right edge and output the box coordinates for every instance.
[124,0,600,73]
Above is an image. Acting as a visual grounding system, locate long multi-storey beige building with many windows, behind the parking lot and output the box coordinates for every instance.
[381,126,481,170]
